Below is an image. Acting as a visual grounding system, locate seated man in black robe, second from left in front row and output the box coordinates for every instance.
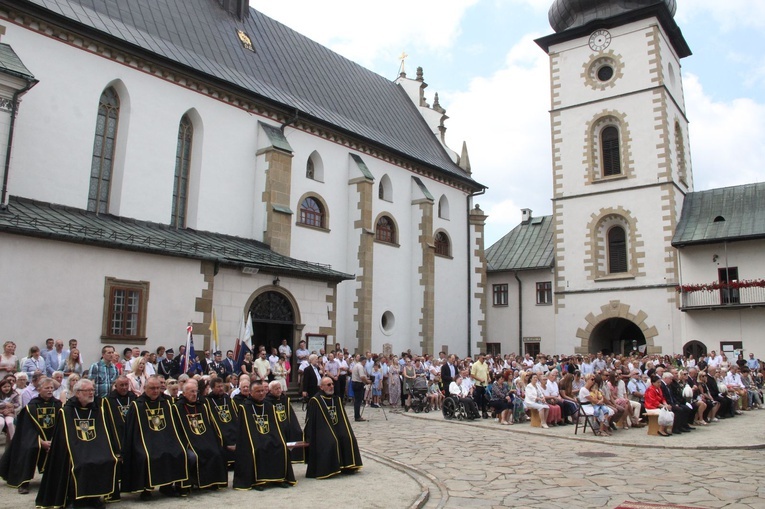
[35,379,118,508]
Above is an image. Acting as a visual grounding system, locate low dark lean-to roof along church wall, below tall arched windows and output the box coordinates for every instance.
[0,197,353,282]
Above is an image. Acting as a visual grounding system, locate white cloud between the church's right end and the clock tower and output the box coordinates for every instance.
[439,34,552,247]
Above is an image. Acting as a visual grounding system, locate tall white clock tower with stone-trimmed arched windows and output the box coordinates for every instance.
[536,0,693,353]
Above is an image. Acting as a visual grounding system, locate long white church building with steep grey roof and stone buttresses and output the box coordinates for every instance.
[0,0,485,361]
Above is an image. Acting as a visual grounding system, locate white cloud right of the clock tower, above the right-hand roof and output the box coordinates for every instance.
[683,74,765,191]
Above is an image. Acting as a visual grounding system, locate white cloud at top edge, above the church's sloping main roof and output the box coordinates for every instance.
[253,0,478,68]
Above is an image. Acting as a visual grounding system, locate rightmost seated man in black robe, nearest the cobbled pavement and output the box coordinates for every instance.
[303,377,361,479]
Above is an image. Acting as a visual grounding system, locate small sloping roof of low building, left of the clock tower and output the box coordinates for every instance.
[486,216,554,272]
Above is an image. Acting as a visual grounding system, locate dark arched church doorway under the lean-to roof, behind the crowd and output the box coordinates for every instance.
[250,292,295,360]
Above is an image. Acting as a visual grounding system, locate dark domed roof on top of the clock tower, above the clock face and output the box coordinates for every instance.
[547,0,677,32]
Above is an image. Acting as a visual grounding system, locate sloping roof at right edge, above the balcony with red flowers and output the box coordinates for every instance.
[672,182,765,247]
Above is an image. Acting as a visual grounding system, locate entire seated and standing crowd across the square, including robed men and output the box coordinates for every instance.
[0,339,765,507]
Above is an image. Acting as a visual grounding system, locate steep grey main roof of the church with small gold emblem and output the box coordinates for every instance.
[18,0,481,187]
